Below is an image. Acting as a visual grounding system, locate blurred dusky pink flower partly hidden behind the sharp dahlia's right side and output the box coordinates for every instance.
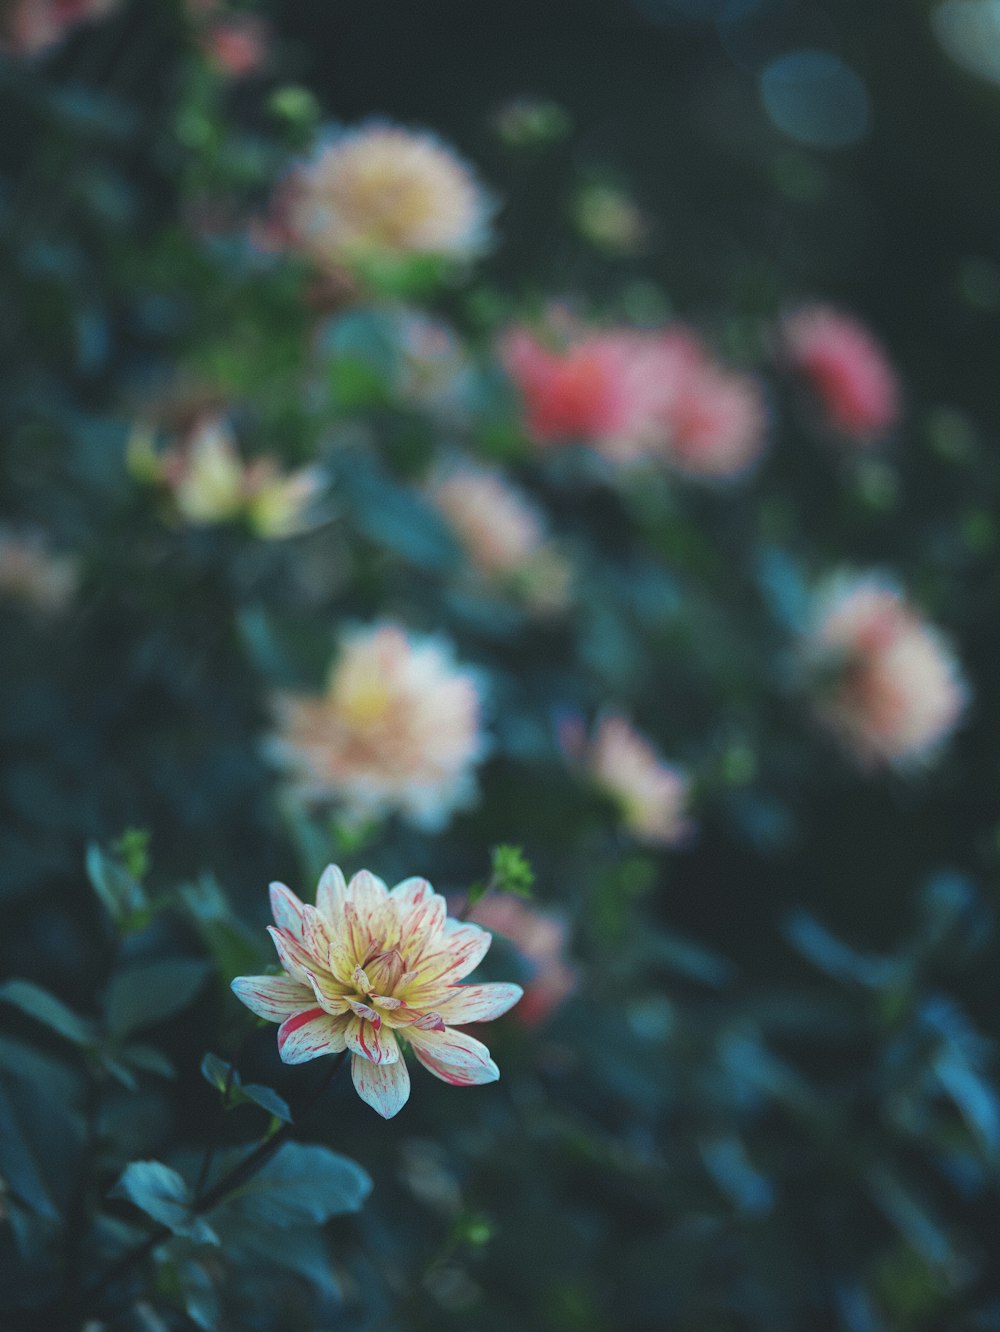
[469,894,578,1027]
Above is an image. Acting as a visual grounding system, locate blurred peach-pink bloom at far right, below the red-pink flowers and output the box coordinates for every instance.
[803,575,968,767]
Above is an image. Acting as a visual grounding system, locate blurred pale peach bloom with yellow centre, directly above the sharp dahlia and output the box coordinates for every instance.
[272,623,485,829]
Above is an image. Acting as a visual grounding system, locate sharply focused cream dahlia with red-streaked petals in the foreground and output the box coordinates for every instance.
[233,864,522,1119]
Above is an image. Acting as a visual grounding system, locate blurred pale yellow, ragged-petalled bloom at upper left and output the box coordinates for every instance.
[128,416,322,538]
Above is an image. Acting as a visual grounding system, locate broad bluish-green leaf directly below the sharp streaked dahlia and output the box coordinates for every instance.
[218,1143,372,1228]
